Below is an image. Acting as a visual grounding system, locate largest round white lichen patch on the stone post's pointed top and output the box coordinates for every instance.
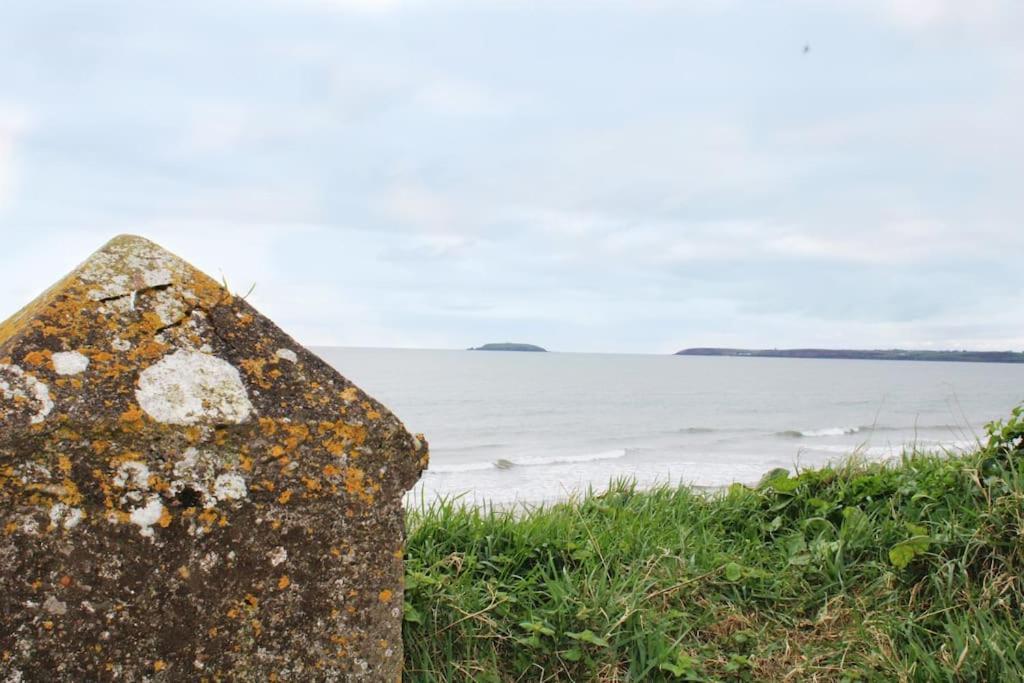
[135,349,253,425]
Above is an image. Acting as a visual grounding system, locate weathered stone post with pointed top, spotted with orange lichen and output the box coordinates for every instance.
[0,237,427,682]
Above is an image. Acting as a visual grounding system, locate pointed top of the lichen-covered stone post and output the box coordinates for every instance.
[0,234,422,491]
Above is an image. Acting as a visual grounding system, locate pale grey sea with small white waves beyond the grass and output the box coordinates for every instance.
[313,347,1024,505]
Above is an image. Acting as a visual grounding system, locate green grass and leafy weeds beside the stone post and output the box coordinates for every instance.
[404,409,1024,682]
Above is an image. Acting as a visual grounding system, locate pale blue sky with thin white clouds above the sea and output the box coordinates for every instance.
[0,0,1024,353]
